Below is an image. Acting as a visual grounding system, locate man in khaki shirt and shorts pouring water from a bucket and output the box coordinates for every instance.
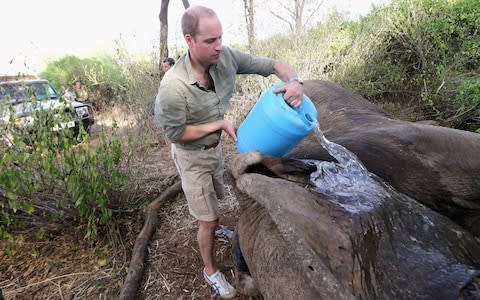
[155,6,303,299]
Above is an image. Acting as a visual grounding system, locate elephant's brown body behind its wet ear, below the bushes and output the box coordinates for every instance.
[288,80,480,236]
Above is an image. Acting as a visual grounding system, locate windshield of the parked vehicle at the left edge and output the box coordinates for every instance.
[0,82,57,103]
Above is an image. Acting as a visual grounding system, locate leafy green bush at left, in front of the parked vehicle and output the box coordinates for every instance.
[0,103,129,241]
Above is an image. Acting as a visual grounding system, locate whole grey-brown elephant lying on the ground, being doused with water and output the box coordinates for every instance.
[228,81,480,299]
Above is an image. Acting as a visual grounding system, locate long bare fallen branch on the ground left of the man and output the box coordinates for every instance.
[119,181,182,300]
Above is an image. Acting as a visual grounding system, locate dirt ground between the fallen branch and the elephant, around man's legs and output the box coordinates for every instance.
[135,137,252,300]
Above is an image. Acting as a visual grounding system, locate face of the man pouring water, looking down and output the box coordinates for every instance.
[185,17,223,66]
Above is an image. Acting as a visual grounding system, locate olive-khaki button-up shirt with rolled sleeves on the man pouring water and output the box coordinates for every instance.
[155,47,275,150]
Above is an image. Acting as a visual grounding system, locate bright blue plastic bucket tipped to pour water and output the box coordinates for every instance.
[237,84,317,157]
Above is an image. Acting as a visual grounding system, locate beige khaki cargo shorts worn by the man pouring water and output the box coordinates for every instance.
[172,144,225,222]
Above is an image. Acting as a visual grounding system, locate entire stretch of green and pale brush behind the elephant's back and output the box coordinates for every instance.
[251,0,480,131]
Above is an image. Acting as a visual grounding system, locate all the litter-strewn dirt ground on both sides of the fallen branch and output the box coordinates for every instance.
[0,102,255,300]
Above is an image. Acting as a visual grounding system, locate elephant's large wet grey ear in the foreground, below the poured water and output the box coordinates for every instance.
[230,152,480,299]
